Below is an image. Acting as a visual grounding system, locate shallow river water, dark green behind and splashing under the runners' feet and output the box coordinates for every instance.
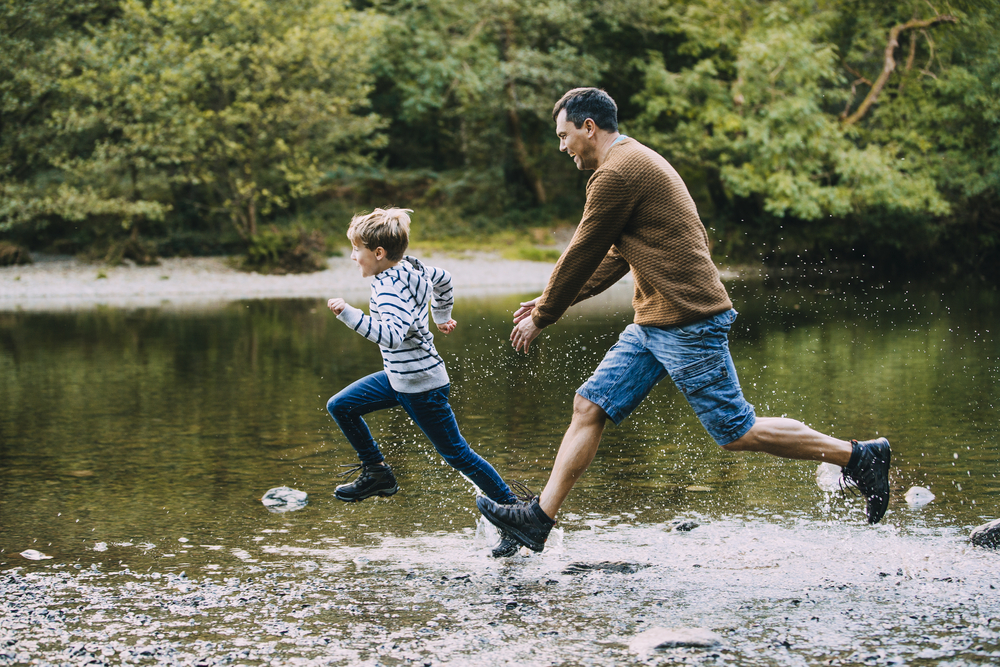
[0,281,1000,665]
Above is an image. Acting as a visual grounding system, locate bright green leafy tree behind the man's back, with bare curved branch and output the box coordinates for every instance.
[629,0,996,266]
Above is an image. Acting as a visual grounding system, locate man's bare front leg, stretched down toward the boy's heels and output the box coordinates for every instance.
[538,394,608,519]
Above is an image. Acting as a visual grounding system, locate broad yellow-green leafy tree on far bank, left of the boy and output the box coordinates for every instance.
[1,0,382,245]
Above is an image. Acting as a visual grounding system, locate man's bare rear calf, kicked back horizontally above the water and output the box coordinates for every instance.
[724,417,851,464]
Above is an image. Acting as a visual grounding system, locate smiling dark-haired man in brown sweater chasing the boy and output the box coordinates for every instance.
[476,88,890,551]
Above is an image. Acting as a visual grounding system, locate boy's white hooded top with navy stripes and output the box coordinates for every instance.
[337,255,454,394]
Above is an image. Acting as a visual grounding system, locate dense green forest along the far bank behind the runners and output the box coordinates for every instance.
[0,0,1000,279]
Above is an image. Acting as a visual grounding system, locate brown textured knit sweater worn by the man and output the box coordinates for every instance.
[531,138,733,327]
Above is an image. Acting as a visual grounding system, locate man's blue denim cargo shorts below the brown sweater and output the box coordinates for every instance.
[576,309,756,445]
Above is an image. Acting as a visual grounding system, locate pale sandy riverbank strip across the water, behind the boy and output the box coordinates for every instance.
[0,252,736,312]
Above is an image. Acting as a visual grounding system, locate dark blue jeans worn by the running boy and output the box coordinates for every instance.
[326,371,517,505]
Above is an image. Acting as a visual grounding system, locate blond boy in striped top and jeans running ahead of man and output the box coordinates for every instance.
[326,208,518,557]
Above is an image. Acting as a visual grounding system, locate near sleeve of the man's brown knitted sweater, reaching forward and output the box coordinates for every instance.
[531,170,635,327]
